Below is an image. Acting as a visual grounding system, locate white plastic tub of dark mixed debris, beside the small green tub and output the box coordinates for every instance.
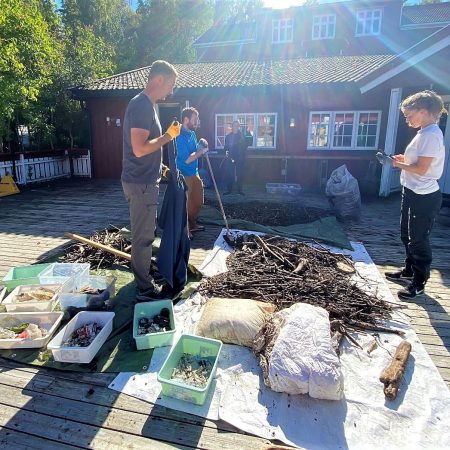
[47,311,114,364]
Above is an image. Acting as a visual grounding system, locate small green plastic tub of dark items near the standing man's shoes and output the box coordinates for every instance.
[133,300,176,350]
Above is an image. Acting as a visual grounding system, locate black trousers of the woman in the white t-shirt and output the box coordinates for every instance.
[400,187,442,285]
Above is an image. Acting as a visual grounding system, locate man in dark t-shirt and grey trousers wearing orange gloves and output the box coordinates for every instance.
[121,61,180,301]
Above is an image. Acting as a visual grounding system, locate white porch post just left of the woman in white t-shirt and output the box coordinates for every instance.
[378,88,402,197]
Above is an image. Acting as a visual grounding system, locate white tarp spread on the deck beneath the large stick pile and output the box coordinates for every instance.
[110,232,450,450]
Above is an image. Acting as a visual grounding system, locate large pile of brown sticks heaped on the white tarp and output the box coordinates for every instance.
[200,235,395,334]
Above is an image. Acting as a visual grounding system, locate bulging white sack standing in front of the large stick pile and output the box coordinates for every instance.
[268,303,344,400]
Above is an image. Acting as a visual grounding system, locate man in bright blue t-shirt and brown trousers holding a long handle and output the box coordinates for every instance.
[176,108,208,239]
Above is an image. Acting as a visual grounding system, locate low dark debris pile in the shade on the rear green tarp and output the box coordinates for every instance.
[206,200,332,226]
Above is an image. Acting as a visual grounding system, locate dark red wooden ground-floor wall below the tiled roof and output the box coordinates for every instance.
[88,84,389,187]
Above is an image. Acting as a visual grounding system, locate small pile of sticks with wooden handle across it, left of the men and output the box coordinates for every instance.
[61,227,131,269]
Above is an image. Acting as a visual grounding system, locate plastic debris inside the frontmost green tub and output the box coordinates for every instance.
[171,353,215,388]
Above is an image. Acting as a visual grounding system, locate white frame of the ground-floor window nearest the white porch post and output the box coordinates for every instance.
[306,110,381,151]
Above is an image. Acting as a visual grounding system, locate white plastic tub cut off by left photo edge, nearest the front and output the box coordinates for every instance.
[0,312,64,350]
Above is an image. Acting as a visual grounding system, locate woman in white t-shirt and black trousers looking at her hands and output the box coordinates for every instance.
[385,91,446,299]
